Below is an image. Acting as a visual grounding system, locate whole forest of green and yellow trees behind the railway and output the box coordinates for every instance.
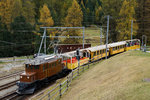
[0,0,150,57]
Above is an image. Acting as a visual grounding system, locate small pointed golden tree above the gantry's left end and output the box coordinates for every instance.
[39,4,54,27]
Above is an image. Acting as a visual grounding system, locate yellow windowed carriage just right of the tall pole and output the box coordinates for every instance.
[109,41,126,55]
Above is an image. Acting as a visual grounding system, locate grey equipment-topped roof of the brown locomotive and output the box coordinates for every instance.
[25,55,60,65]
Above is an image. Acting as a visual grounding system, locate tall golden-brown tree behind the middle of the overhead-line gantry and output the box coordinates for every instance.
[63,0,83,43]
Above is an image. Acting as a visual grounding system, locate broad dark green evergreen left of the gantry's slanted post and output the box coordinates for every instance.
[11,16,34,56]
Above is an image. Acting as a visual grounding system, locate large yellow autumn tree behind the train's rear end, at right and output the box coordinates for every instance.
[116,0,138,40]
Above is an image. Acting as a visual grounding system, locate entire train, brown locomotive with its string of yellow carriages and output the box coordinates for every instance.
[16,39,140,94]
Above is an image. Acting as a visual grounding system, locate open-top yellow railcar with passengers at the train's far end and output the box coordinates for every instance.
[125,39,140,51]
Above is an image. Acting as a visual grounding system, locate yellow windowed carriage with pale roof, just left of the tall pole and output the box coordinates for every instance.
[87,45,109,61]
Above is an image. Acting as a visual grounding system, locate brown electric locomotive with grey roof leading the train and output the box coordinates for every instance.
[17,55,64,94]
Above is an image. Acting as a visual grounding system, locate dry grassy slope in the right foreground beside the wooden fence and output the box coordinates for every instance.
[61,51,150,100]
